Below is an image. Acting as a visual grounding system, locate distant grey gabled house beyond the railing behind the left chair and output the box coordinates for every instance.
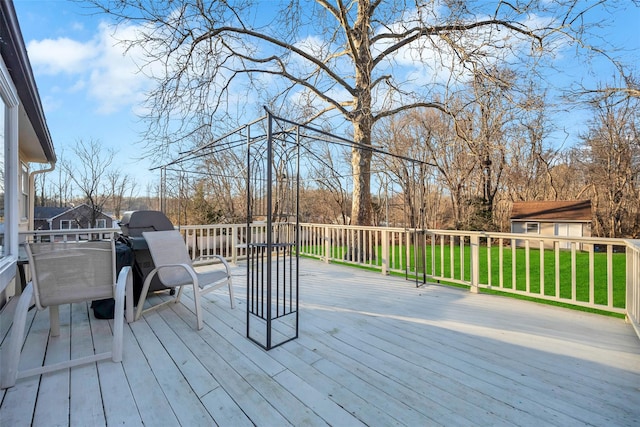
[33,204,113,230]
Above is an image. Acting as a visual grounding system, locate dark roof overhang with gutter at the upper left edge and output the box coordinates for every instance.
[0,1,56,163]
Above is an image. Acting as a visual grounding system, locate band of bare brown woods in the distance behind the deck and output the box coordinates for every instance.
[36,88,640,238]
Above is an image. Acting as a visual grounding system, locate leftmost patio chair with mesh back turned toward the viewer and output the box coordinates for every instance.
[0,241,133,388]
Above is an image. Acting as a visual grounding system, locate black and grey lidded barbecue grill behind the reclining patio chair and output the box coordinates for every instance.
[120,211,175,304]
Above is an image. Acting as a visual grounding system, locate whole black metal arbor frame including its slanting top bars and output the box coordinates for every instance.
[159,111,436,350]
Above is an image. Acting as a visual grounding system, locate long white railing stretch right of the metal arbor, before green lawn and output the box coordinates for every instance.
[300,224,639,314]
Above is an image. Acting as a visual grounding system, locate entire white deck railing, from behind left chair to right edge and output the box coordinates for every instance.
[21,223,640,336]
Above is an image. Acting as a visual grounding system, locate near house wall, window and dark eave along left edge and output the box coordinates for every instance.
[0,0,56,307]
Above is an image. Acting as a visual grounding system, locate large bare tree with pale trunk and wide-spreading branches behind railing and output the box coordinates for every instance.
[86,0,632,229]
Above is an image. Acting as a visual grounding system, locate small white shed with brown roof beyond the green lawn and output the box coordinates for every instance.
[511,200,592,249]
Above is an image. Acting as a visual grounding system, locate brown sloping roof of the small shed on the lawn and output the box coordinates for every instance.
[511,200,591,222]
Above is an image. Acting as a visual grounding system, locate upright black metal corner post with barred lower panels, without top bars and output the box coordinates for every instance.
[247,113,300,350]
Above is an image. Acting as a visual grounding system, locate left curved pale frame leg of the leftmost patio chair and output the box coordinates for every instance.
[0,282,34,389]
